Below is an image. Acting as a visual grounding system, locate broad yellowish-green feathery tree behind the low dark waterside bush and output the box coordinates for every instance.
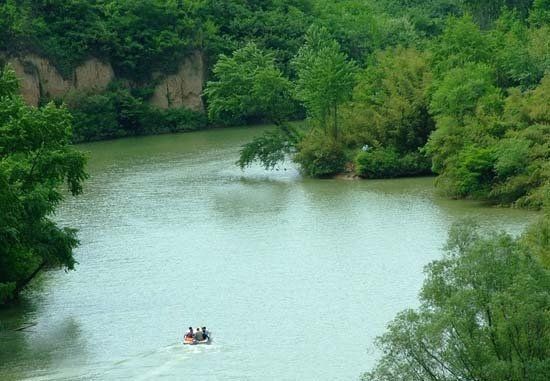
[343,48,434,153]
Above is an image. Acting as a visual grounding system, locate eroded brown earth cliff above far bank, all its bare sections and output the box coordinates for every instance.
[6,52,205,112]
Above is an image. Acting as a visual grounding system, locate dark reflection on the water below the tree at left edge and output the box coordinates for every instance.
[0,302,85,380]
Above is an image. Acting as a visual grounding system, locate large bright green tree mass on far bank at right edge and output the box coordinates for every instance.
[420,13,550,207]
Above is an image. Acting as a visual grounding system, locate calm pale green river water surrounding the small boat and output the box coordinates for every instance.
[0,129,535,380]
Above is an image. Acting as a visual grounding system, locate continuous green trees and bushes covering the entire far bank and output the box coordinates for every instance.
[0,0,550,208]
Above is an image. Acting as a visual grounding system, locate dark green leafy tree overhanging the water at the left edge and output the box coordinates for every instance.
[0,66,86,304]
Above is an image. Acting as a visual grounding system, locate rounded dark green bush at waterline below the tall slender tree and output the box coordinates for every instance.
[294,134,347,177]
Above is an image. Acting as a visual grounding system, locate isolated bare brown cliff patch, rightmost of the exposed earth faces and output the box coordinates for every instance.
[150,52,205,112]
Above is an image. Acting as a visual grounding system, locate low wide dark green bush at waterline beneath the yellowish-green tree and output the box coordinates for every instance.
[355,148,436,179]
